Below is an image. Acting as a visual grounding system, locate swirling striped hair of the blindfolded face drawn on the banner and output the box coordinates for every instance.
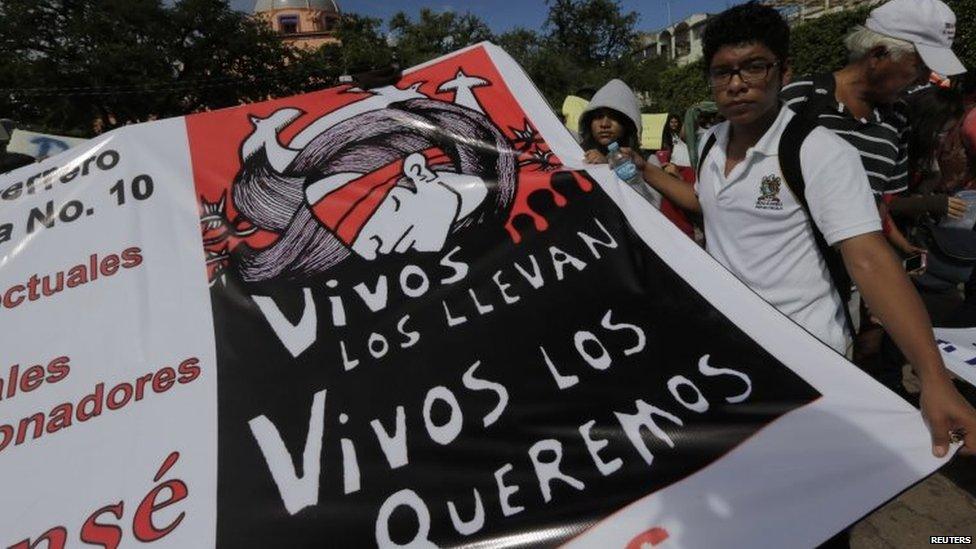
[232,99,518,282]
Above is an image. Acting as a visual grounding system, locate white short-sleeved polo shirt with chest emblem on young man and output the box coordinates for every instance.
[695,108,881,354]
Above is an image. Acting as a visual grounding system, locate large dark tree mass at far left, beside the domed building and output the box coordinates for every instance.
[0,0,301,136]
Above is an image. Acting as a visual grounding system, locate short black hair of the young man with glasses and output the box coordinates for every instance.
[702,0,790,70]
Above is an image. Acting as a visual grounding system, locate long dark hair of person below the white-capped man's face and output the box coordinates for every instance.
[905,86,965,179]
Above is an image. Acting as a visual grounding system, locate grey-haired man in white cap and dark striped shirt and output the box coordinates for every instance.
[781,0,966,372]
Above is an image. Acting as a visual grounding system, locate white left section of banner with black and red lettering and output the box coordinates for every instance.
[0,118,217,549]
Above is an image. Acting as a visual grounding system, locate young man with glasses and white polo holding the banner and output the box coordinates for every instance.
[643,2,976,456]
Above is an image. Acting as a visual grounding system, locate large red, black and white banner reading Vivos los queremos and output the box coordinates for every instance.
[0,44,943,549]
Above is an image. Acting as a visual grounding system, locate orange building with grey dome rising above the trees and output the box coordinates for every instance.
[254,0,341,49]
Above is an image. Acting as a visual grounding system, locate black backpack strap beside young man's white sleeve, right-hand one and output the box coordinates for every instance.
[779,116,856,337]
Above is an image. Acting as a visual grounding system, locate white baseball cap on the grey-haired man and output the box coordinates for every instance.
[864,0,966,76]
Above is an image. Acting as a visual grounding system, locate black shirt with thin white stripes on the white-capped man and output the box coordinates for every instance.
[780,74,909,194]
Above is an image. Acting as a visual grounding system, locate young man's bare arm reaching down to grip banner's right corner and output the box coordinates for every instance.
[838,232,976,457]
